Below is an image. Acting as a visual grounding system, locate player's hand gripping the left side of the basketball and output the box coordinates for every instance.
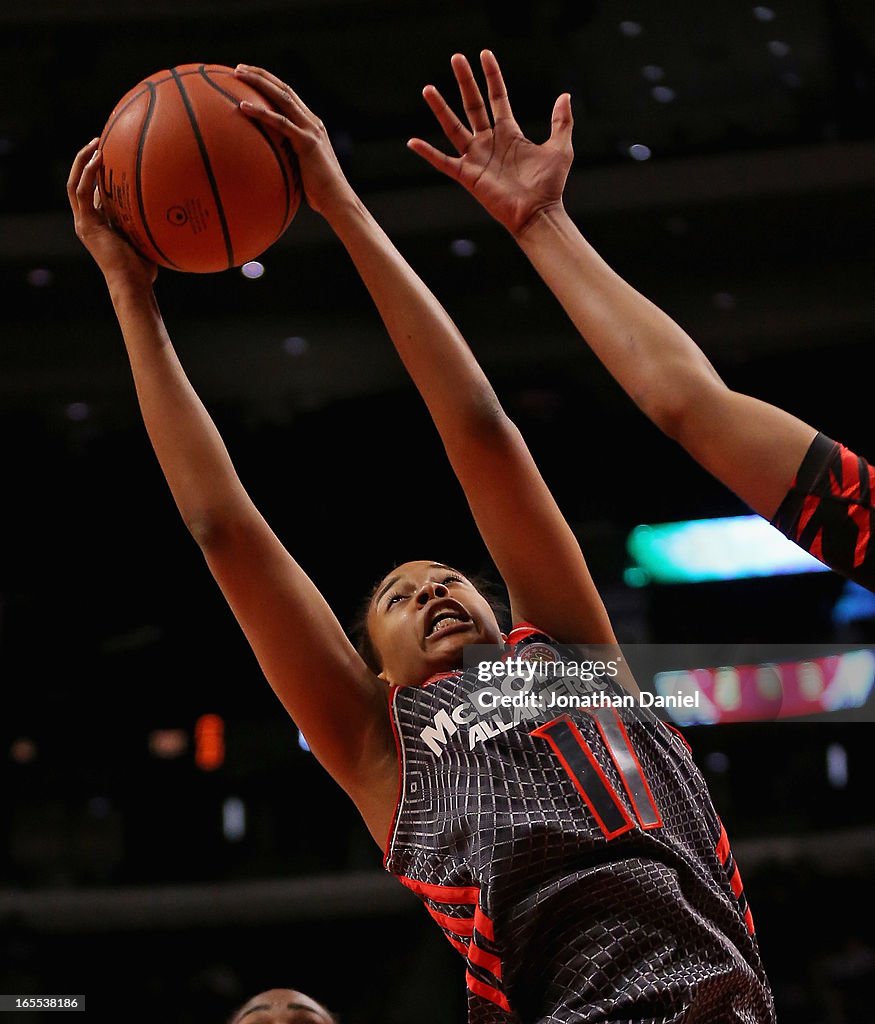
[67,138,158,288]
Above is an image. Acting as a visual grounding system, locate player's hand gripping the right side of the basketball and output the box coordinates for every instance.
[235,65,351,215]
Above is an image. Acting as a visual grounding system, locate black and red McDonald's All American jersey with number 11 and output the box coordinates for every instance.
[385,627,775,1024]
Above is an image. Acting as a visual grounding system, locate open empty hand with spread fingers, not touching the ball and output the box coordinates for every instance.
[407,50,574,236]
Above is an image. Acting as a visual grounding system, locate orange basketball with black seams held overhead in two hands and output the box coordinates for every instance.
[97,63,301,273]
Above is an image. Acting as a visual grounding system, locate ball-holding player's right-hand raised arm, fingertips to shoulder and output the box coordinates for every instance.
[238,68,613,643]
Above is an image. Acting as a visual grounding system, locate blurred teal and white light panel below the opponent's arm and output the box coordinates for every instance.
[625,515,829,587]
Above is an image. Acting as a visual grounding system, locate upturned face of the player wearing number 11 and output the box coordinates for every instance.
[368,561,501,686]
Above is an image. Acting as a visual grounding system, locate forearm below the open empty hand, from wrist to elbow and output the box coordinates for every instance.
[516,207,721,433]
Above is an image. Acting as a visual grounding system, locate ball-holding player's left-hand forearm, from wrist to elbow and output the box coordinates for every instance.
[108,280,248,531]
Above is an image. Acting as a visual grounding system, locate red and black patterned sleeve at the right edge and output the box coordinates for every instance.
[772,434,875,591]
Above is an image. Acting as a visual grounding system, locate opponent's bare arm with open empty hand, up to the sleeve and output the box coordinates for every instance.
[409,50,816,519]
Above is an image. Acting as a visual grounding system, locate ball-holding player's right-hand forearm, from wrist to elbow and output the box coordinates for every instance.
[329,197,503,443]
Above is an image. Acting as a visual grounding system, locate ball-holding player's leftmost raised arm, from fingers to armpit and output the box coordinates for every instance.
[68,139,395,843]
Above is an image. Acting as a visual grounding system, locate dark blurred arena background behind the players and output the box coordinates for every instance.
[0,0,875,1024]
